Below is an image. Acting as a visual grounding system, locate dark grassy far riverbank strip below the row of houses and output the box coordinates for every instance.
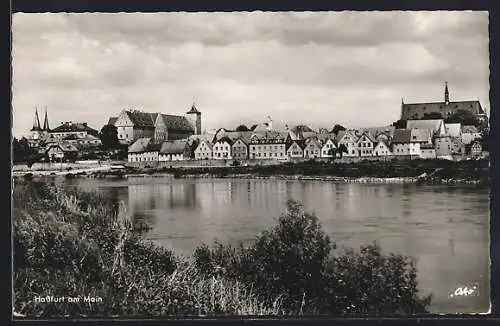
[17,160,490,184]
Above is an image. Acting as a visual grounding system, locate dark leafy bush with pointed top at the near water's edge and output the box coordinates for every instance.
[194,201,431,314]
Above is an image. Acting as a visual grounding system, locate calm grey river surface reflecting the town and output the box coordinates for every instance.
[60,177,490,313]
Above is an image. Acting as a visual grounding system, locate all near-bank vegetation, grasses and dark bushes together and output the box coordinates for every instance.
[13,180,432,318]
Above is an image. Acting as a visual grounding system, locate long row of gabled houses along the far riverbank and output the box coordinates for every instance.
[128,119,481,162]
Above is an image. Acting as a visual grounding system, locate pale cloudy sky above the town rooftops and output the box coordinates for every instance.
[12,11,490,136]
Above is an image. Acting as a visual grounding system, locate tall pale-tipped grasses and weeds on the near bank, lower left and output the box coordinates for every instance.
[13,182,281,317]
